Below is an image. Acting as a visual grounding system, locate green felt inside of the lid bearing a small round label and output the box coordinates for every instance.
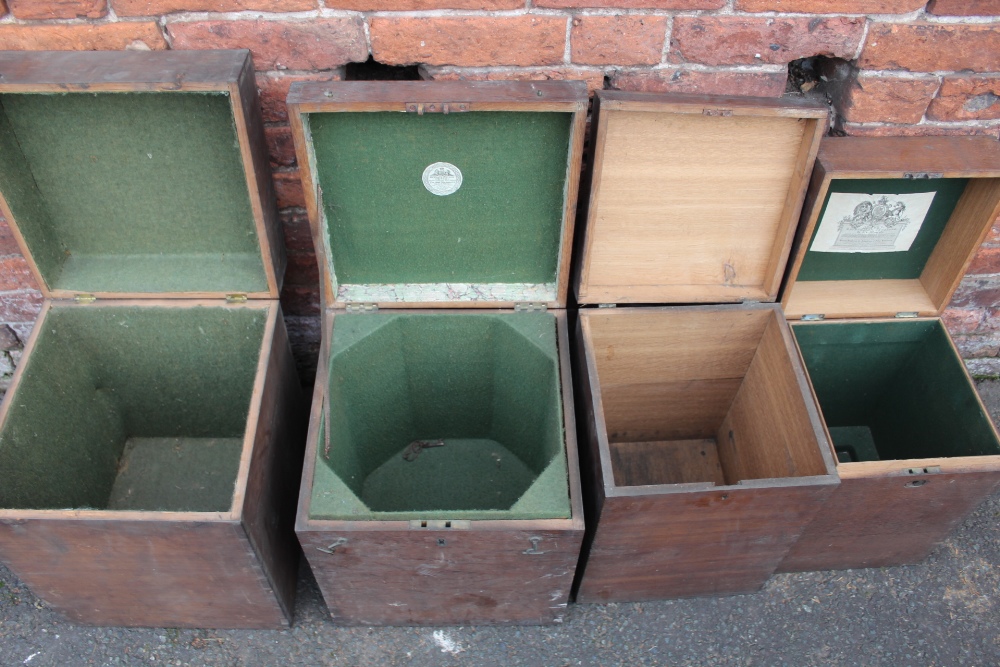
[303,111,573,302]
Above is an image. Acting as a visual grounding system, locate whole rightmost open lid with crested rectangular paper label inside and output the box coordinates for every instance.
[782,137,1000,319]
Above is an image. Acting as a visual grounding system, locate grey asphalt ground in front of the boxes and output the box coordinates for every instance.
[0,381,1000,667]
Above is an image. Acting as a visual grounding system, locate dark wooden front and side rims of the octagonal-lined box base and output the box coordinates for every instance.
[296,311,584,625]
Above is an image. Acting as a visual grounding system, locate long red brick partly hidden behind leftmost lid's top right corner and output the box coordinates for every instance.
[167,17,368,71]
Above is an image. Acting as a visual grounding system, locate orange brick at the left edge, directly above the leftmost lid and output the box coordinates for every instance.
[0,21,167,51]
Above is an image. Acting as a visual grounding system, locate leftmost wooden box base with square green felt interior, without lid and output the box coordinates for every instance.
[0,300,304,628]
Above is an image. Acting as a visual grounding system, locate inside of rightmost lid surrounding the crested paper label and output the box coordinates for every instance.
[785,178,1000,317]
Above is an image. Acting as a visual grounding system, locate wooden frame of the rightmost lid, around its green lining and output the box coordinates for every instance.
[781,137,1000,319]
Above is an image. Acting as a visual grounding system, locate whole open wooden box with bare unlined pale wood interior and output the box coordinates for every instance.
[575,92,837,602]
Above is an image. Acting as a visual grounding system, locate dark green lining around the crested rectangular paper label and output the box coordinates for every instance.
[796,178,968,280]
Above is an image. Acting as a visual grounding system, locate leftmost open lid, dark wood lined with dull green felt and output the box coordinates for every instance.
[0,50,284,298]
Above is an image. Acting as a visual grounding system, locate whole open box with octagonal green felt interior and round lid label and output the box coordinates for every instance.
[288,82,587,625]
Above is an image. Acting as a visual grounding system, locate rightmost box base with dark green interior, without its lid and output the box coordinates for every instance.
[779,318,1000,572]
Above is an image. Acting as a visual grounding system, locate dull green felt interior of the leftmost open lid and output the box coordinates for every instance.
[0,92,268,293]
